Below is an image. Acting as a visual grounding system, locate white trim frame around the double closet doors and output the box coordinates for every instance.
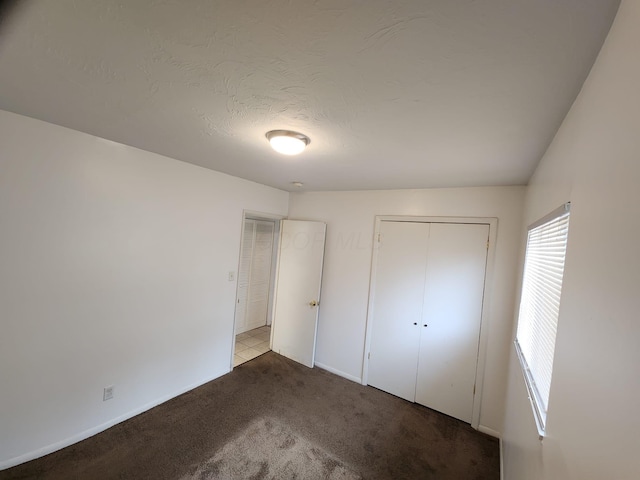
[362,215,498,430]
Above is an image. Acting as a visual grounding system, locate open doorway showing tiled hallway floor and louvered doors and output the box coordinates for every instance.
[233,213,280,367]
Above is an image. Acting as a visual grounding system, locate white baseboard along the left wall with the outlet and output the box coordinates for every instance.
[0,370,231,470]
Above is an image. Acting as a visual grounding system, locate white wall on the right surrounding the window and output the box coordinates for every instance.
[504,0,640,480]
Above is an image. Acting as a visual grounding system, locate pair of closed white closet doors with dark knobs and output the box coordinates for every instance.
[367,221,489,423]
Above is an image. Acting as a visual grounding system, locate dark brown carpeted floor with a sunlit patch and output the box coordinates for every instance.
[0,352,500,480]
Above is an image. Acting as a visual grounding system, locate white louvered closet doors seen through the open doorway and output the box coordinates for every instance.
[235,218,275,334]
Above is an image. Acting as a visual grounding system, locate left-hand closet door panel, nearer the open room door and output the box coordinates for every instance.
[367,222,430,402]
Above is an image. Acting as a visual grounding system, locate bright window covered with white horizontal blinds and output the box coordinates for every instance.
[515,203,569,437]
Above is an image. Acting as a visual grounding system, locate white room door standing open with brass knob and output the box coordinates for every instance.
[271,220,326,367]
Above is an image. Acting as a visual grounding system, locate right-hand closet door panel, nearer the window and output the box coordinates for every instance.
[415,223,489,423]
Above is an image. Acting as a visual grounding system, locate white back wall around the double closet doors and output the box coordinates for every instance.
[289,187,524,432]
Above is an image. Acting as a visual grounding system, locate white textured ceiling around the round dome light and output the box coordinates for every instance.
[0,0,619,190]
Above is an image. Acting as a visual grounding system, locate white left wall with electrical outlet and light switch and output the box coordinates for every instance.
[0,111,288,468]
